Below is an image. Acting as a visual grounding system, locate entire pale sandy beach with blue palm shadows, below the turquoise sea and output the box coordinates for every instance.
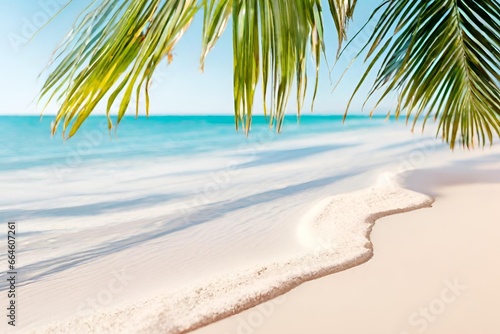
[1,123,500,334]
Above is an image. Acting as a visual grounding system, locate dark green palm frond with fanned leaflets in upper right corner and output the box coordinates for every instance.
[347,0,500,148]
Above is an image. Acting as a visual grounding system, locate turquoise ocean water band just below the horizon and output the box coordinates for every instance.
[0,116,386,170]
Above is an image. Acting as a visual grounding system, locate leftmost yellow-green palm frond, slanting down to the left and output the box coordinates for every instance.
[41,0,199,137]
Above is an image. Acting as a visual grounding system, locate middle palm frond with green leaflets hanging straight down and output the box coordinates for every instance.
[228,0,323,132]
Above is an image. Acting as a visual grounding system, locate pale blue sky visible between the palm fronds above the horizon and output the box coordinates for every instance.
[0,0,387,115]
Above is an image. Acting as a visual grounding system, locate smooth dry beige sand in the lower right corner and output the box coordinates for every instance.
[193,155,500,334]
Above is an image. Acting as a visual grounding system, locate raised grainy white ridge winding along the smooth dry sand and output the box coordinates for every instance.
[36,179,433,334]
